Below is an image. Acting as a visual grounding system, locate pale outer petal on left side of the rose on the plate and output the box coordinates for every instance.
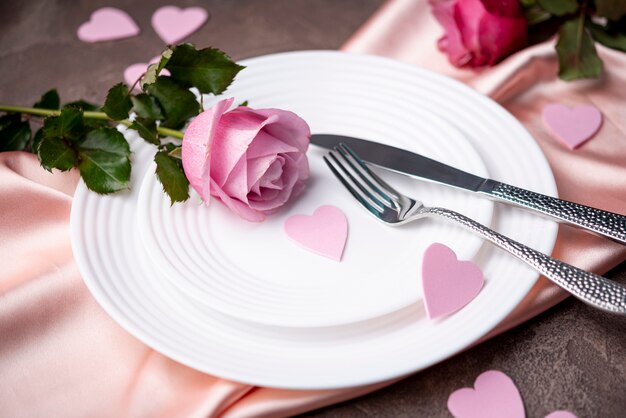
[182,98,233,204]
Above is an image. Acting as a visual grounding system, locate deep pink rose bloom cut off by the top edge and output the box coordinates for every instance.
[430,0,527,67]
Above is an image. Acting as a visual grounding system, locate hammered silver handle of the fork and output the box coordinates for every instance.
[422,208,626,314]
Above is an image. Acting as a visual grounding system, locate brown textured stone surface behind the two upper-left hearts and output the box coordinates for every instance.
[0,0,382,104]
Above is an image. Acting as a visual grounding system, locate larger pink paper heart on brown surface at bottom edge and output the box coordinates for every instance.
[448,370,525,418]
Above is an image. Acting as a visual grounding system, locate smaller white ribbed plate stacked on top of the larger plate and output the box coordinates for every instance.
[137,84,493,327]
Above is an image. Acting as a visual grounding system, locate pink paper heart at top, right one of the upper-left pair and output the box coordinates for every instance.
[152,6,209,45]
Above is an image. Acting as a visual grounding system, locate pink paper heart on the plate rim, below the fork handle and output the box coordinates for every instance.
[422,243,485,319]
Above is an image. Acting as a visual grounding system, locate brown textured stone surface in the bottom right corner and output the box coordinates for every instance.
[306,292,626,418]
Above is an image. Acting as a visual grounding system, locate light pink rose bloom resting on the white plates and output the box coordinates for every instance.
[182,99,311,222]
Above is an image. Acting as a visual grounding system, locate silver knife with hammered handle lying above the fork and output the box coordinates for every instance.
[311,134,626,244]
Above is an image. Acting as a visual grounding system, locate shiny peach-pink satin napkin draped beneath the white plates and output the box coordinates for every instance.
[0,0,626,418]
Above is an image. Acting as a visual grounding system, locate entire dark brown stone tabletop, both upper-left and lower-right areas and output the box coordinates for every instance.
[0,0,626,418]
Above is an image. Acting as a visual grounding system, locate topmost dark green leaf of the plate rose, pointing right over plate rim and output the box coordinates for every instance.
[165,44,244,94]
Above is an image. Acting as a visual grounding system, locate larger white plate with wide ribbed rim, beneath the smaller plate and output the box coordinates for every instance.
[72,52,557,389]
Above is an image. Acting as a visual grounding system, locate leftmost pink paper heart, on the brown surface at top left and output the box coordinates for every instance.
[77,7,139,42]
